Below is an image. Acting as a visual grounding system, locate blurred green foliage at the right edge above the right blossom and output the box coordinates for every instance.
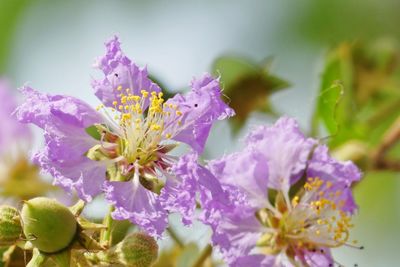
[313,40,400,152]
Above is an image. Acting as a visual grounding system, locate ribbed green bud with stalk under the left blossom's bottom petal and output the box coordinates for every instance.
[87,233,158,267]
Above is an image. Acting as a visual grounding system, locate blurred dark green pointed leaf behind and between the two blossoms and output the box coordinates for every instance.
[212,56,289,133]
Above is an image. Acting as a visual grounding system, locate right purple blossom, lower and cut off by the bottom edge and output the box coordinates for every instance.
[202,118,361,266]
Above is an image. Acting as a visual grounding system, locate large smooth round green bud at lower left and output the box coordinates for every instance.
[21,197,77,253]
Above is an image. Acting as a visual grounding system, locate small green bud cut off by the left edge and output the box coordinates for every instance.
[0,205,22,246]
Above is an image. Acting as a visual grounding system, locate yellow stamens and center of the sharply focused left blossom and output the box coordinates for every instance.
[90,86,182,184]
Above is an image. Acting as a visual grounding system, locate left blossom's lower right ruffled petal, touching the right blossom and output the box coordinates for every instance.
[160,154,230,227]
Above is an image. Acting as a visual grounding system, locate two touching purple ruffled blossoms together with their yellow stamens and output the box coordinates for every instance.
[16,37,361,267]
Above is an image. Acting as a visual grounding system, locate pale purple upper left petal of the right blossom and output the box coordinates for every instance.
[208,148,268,209]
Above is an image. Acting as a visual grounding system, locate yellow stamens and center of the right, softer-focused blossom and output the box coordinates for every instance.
[256,178,355,256]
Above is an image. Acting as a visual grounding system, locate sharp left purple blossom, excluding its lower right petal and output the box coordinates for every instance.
[16,37,234,235]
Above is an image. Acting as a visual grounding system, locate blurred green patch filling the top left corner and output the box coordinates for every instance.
[0,0,30,73]
